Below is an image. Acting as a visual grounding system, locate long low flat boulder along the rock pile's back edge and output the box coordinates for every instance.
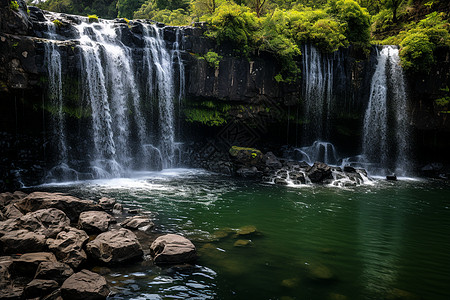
[17,192,101,223]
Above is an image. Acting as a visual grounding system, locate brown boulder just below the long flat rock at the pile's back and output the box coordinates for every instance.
[18,208,70,238]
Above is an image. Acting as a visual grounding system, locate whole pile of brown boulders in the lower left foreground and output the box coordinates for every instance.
[0,192,197,299]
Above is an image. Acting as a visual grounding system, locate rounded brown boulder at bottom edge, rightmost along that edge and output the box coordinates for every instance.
[61,270,109,300]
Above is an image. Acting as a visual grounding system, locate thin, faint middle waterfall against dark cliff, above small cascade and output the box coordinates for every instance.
[302,45,333,144]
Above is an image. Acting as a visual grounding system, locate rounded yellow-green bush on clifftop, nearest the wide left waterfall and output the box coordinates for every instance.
[207,3,259,55]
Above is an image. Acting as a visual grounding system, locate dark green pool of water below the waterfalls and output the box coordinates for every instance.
[36,169,450,300]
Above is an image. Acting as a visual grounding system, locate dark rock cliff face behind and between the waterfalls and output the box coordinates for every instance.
[0,0,450,190]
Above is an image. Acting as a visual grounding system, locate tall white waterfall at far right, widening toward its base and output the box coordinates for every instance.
[363,46,410,174]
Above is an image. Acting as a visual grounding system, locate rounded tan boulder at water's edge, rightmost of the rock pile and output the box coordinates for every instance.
[150,234,197,264]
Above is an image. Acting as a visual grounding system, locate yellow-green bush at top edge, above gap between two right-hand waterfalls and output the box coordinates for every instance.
[328,0,370,48]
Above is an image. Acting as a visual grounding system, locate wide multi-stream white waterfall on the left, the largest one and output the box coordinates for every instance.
[41,15,184,180]
